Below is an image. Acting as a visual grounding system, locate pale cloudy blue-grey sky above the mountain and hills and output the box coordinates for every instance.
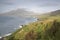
[0,0,60,13]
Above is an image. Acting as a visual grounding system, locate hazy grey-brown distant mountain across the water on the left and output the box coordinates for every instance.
[0,9,34,16]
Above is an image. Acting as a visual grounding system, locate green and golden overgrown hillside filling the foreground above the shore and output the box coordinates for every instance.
[4,9,60,40]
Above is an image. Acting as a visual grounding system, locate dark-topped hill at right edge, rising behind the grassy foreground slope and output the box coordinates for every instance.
[37,10,60,20]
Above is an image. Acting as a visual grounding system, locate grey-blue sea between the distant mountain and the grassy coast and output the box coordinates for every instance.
[0,16,35,36]
